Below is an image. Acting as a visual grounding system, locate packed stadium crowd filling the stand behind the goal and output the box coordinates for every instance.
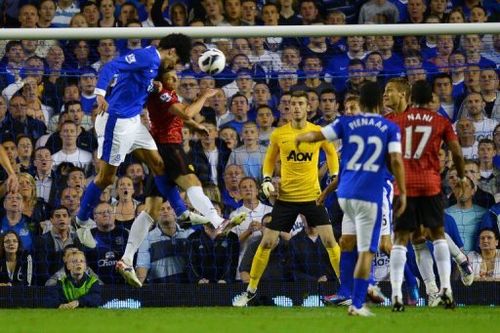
[0,0,500,302]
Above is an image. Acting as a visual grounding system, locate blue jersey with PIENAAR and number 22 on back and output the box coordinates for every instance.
[321,113,401,203]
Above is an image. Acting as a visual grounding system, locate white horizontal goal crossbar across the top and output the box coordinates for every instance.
[0,23,500,40]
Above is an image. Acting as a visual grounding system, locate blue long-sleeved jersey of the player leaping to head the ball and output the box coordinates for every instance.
[96,46,160,118]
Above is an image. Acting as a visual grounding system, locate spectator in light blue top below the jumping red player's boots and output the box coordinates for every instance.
[135,201,193,283]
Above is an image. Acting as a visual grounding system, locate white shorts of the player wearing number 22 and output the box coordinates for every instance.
[339,198,382,253]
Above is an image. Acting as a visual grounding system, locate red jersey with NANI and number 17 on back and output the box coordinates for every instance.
[391,108,458,197]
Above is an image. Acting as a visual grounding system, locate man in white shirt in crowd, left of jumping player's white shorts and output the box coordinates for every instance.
[52,120,92,172]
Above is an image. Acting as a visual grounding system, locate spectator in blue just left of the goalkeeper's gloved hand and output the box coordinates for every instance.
[219,164,245,216]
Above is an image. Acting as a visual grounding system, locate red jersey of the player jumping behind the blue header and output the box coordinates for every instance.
[147,89,184,143]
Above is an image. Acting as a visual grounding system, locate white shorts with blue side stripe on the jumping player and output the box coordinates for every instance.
[95,112,158,166]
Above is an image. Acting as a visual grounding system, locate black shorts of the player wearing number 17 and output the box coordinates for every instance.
[394,193,444,231]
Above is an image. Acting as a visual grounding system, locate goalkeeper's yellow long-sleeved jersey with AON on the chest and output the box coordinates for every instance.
[263,122,339,202]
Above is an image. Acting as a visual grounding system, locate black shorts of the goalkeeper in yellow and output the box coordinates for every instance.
[266,200,330,232]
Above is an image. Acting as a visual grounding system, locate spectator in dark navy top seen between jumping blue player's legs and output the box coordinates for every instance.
[87,202,129,284]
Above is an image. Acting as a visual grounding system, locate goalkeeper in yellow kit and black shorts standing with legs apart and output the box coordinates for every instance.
[233,91,340,307]
